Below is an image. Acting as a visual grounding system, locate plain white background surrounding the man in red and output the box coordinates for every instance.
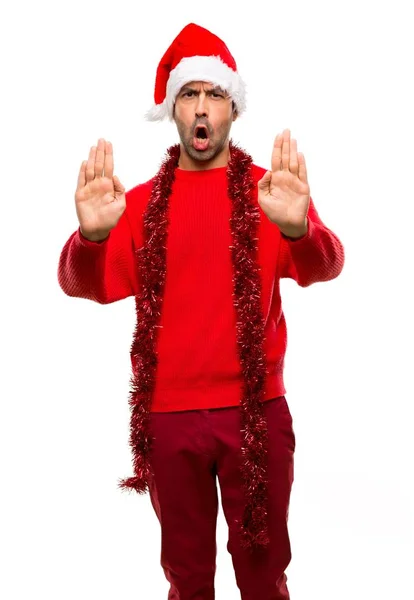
[0,0,414,600]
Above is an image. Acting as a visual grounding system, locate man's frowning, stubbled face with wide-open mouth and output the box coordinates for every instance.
[174,81,237,161]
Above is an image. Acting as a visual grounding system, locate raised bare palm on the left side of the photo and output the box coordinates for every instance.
[75,139,126,242]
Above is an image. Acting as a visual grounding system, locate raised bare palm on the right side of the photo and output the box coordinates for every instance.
[258,129,310,238]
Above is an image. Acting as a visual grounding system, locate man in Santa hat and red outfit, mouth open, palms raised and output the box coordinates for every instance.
[58,24,344,600]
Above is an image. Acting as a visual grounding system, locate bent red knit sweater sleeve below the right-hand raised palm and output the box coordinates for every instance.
[278,198,345,287]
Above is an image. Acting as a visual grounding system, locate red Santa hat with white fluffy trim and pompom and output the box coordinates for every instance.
[145,23,246,121]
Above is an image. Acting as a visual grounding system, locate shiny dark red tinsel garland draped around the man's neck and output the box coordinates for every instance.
[119,141,269,550]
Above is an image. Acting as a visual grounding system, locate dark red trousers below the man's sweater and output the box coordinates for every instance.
[150,396,295,600]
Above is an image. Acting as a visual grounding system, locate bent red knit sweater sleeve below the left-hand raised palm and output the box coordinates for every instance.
[58,199,138,304]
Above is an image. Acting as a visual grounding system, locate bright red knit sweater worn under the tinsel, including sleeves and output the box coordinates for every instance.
[58,165,344,412]
